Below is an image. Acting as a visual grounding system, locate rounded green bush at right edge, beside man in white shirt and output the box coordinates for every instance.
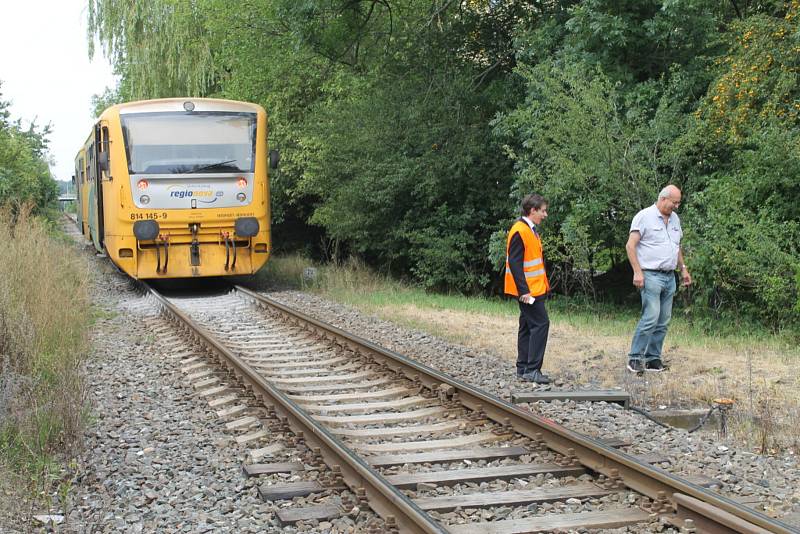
[687,128,800,327]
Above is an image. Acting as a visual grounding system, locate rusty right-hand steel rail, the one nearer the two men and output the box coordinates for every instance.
[235,285,800,534]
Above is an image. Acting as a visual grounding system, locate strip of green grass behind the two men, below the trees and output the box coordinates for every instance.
[258,255,800,359]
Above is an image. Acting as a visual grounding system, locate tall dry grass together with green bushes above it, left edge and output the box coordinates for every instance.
[0,87,89,521]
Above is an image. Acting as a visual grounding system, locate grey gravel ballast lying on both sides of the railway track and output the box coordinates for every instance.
[39,231,800,532]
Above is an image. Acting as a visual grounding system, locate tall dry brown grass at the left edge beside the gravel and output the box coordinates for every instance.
[0,205,90,502]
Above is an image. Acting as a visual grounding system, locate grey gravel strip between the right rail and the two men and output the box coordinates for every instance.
[264,291,800,527]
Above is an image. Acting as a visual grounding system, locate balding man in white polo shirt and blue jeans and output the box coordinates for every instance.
[625,185,692,373]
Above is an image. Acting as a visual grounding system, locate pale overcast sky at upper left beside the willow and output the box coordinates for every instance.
[0,0,114,180]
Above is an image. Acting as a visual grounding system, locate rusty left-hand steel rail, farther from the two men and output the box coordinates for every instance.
[144,283,447,534]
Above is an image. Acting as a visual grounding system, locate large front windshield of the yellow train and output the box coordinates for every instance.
[121,111,256,174]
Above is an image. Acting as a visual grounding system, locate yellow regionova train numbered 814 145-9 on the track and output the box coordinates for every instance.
[73,98,278,279]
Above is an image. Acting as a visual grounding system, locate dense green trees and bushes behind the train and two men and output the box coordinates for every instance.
[89,0,800,331]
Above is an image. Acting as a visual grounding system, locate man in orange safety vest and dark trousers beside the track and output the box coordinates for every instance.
[505,194,551,384]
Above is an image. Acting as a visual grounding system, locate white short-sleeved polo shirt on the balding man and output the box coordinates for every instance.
[630,204,683,271]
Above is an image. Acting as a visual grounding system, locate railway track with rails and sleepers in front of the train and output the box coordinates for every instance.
[148,286,797,534]
